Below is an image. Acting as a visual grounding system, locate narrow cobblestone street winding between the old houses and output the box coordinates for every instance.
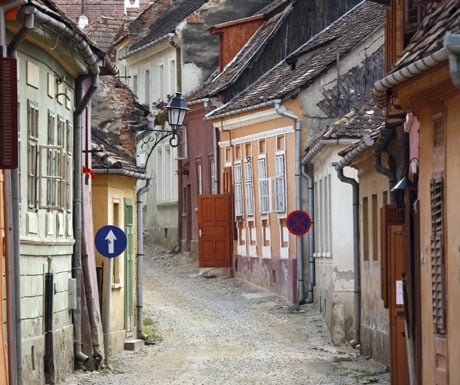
[66,246,389,385]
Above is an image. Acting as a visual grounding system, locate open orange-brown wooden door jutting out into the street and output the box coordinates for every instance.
[198,194,232,267]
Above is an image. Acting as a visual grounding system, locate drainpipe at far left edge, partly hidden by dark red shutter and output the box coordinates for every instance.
[0,0,29,385]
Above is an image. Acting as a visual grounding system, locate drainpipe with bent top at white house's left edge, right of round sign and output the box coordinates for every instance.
[301,138,356,303]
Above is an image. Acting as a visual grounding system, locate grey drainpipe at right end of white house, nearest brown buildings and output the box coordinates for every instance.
[334,135,374,348]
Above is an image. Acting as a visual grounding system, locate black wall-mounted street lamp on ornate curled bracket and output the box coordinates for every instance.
[139,92,189,167]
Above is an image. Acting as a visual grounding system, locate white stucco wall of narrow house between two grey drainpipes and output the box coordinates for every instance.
[311,145,357,344]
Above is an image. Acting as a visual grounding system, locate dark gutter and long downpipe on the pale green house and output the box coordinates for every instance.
[35,9,100,364]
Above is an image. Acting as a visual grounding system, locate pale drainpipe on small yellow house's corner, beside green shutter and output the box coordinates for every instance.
[136,176,153,340]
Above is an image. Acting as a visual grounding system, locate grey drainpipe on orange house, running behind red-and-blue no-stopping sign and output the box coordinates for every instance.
[273,99,305,305]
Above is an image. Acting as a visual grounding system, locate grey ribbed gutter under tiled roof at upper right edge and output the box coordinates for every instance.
[373,32,460,108]
